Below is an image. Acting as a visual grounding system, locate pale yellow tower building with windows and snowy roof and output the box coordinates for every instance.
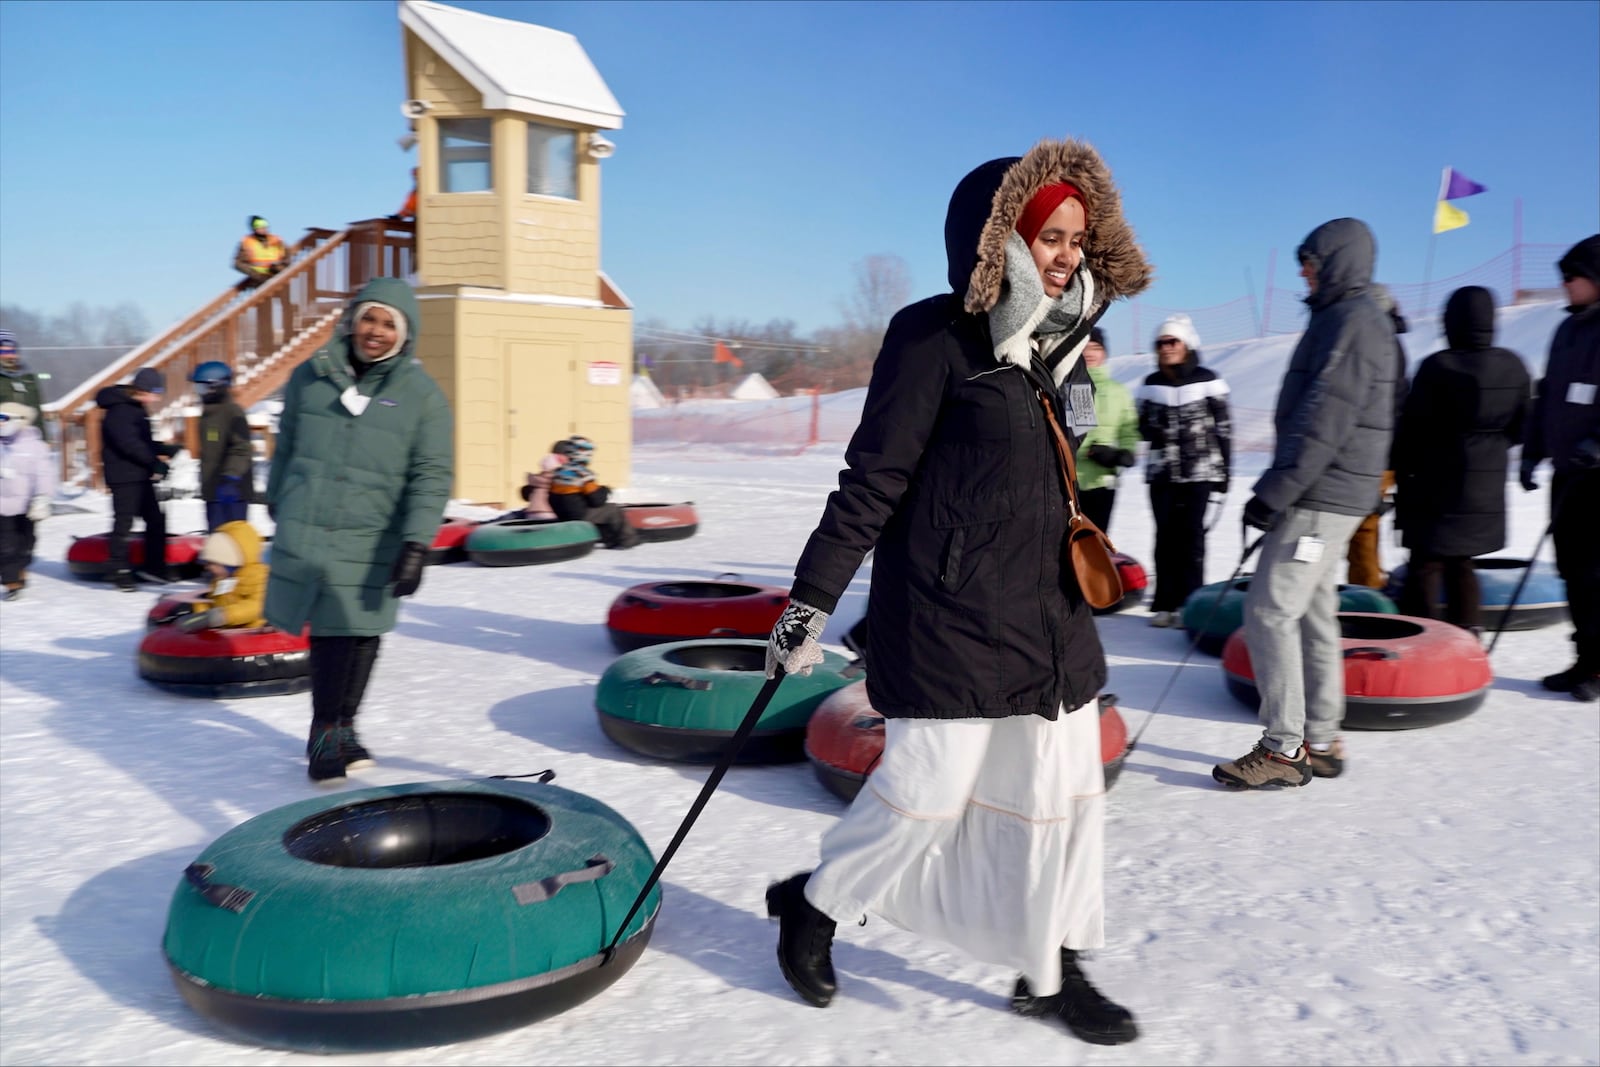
[400,0,634,506]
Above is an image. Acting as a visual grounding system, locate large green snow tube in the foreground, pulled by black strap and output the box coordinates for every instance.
[162,776,661,1053]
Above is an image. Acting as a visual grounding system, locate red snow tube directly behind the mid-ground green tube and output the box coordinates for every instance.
[606,579,789,653]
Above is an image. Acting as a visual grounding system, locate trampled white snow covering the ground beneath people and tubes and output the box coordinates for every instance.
[0,302,1600,1064]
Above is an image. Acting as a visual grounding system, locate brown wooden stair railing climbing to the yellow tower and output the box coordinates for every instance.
[51,219,416,488]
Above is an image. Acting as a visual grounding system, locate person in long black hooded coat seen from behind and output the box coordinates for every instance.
[1392,285,1530,630]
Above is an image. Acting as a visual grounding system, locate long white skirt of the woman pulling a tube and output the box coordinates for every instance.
[805,705,1106,995]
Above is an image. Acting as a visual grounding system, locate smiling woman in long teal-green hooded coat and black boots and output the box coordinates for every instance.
[266,278,454,782]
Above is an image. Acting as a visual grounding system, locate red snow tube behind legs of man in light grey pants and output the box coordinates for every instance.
[1222,611,1494,729]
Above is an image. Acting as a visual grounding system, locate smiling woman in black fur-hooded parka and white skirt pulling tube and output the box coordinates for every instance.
[766,141,1149,1045]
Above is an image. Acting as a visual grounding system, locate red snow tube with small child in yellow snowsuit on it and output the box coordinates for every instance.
[139,611,310,696]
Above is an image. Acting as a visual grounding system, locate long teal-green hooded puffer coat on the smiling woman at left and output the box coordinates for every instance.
[266,278,454,637]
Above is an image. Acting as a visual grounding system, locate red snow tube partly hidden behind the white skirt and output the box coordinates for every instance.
[805,678,1128,800]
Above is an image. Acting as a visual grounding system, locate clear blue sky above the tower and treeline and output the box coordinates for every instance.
[0,0,1600,350]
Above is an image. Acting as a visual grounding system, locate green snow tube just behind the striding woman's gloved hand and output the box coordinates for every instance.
[595,638,858,763]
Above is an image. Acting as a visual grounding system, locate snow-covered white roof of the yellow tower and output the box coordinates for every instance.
[400,0,624,130]
